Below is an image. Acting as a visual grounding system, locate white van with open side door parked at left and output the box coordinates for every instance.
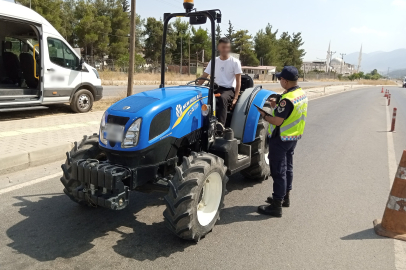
[0,0,103,113]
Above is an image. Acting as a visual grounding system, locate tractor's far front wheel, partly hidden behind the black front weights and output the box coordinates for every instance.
[61,133,106,206]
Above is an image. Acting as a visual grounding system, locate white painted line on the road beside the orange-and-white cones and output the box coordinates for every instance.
[386,106,406,270]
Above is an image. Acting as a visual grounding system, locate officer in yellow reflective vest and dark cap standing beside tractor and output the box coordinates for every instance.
[258,66,308,217]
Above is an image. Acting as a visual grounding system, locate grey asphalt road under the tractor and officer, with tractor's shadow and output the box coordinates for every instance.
[0,87,406,269]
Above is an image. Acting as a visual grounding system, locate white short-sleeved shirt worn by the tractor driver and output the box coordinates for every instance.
[204,56,242,88]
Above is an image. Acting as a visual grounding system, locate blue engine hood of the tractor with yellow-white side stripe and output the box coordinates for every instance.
[99,86,209,152]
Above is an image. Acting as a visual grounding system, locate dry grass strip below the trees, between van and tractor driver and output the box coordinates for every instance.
[100,71,196,85]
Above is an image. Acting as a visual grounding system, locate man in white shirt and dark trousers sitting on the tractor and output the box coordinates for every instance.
[199,38,242,129]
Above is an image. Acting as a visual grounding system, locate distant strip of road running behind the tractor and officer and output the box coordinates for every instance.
[103,82,348,98]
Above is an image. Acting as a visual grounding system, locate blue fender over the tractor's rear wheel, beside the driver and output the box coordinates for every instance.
[231,86,275,143]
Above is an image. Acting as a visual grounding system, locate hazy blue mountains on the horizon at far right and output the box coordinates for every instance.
[344,49,406,75]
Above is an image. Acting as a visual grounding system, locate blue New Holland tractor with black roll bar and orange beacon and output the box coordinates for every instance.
[61,0,275,241]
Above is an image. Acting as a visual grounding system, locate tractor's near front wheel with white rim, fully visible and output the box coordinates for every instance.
[163,152,228,242]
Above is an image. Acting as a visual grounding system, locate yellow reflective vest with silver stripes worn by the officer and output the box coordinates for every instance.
[268,88,308,141]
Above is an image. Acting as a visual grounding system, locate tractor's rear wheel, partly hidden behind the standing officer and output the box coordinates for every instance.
[241,102,272,181]
